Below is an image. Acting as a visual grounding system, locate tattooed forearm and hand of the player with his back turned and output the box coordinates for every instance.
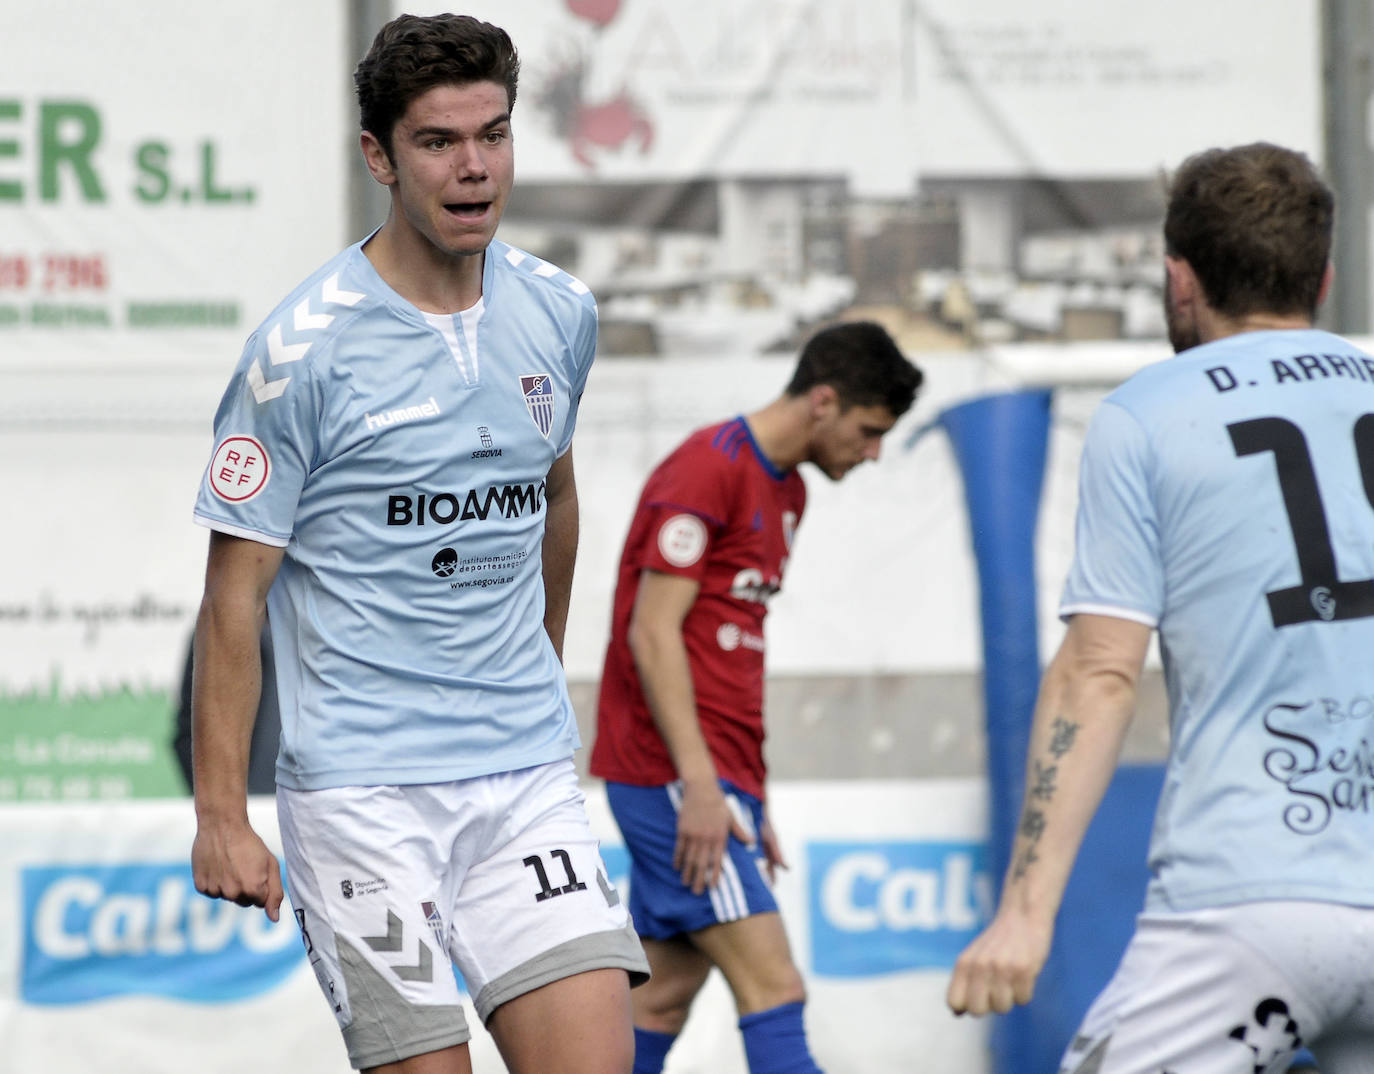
[947,615,1150,1015]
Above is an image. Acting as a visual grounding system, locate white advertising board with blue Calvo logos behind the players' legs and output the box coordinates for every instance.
[0,780,989,1074]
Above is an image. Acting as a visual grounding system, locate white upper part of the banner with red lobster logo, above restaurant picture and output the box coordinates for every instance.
[396,0,1322,184]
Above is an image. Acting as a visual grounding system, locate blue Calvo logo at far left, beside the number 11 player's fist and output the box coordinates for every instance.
[21,862,305,1005]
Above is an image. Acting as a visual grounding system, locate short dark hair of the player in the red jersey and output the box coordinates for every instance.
[786,321,925,418]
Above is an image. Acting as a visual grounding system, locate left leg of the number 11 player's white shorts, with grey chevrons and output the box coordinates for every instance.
[278,787,469,1070]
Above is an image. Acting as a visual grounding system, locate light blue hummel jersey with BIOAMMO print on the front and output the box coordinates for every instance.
[195,242,596,790]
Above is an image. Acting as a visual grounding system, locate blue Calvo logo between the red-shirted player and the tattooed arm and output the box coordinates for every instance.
[807,841,992,976]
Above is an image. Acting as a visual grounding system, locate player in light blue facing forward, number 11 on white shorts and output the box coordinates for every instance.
[192,15,647,1074]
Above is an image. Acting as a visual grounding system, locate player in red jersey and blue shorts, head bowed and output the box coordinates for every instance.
[591,323,922,1074]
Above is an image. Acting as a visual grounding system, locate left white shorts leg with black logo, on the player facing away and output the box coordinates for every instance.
[1061,911,1312,1074]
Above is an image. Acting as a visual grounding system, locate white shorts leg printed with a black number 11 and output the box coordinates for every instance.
[449,761,649,1031]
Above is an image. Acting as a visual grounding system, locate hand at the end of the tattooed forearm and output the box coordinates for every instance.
[945,911,1054,1015]
